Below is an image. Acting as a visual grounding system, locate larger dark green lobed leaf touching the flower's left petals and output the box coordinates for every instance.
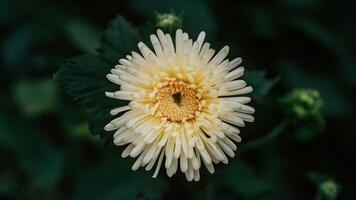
[54,55,124,136]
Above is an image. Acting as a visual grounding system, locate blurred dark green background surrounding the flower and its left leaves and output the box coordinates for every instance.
[0,0,356,200]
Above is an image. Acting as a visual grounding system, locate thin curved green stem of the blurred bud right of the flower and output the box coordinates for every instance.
[242,119,289,150]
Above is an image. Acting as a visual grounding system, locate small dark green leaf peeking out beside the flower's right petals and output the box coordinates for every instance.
[244,70,279,103]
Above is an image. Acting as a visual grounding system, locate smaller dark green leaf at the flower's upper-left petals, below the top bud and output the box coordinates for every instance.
[99,16,140,63]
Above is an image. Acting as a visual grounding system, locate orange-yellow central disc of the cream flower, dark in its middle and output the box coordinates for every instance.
[155,80,201,122]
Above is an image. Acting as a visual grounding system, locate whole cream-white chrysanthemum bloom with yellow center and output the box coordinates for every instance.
[105,30,255,181]
